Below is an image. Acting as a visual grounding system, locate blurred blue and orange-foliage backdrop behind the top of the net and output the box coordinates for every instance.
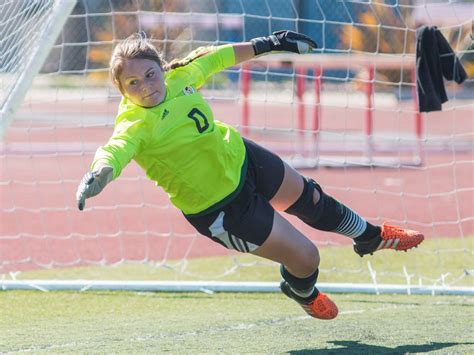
[43,0,474,85]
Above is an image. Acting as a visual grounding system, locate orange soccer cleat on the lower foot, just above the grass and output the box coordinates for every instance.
[280,281,339,319]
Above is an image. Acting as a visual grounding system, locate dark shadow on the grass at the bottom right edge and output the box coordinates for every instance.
[289,340,474,355]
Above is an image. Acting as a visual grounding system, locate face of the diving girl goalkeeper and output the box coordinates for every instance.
[119,59,166,107]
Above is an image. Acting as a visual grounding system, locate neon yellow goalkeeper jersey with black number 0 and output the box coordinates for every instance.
[92,45,246,215]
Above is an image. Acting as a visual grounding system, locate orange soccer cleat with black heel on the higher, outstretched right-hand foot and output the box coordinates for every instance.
[354,223,425,256]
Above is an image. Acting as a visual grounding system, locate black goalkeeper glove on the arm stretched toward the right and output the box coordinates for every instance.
[250,30,318,55]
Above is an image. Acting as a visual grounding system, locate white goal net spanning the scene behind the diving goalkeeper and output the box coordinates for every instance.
[0,0,474,292]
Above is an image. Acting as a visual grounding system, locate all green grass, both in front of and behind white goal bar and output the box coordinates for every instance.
[0,238,474,354]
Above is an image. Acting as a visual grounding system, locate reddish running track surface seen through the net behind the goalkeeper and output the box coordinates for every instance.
[0,89,474,272]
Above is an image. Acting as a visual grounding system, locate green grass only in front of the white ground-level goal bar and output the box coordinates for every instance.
[0,291,474,354]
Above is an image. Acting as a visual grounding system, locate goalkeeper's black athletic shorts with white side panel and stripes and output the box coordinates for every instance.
[185,138,285,253]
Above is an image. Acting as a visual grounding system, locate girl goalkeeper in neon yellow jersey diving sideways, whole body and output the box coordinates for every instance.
[76,31,423,319]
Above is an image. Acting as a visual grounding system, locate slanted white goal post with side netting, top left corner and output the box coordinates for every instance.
[0,0,76,137]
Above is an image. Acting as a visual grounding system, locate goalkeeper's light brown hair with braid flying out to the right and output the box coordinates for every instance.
[110,31,210,93]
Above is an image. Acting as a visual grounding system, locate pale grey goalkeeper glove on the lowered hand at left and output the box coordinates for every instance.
[76,166,113,211]
